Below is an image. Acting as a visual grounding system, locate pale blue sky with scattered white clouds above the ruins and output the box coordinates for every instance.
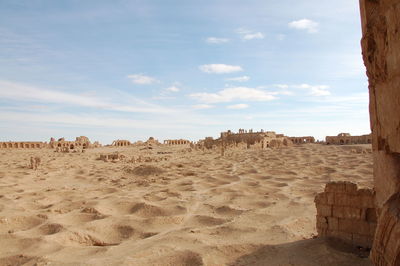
[0,0,370,144]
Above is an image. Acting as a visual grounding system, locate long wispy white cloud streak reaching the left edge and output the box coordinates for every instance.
[0,80,172,113]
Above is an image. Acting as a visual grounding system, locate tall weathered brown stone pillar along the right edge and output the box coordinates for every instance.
[360,0,400,265]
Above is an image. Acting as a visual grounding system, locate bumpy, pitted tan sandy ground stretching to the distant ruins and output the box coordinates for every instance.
[0,144,372,266]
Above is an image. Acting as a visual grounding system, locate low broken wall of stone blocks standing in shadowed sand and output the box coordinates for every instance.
[315,182,377,248]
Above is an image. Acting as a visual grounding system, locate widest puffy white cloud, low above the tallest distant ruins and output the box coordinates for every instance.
[189,87,276,103]
